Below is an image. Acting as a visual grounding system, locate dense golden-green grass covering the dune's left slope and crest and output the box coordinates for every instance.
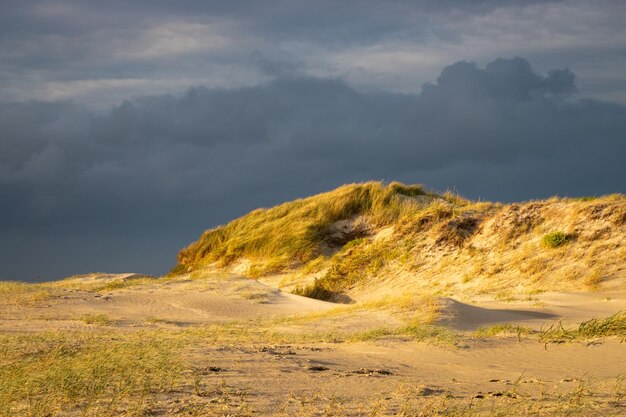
[174,182,430,272]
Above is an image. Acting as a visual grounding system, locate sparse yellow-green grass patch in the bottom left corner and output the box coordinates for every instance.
[0,332,181,417]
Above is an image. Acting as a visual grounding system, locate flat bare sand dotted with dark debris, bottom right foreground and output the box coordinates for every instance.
[176,340,626,416]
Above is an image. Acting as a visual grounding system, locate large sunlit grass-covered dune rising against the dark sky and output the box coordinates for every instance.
[168,182,626,301]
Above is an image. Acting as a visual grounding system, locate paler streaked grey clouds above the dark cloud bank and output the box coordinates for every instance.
[0,0,626,110]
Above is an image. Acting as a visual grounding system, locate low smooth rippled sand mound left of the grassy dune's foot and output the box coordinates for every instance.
[0,274,335,330]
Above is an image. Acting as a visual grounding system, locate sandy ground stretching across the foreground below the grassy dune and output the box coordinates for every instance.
[0,274,626,416]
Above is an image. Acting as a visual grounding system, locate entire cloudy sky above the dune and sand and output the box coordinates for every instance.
[0,0,626,281]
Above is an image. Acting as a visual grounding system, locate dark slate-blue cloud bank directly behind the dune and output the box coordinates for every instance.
[0,58,626,280]
